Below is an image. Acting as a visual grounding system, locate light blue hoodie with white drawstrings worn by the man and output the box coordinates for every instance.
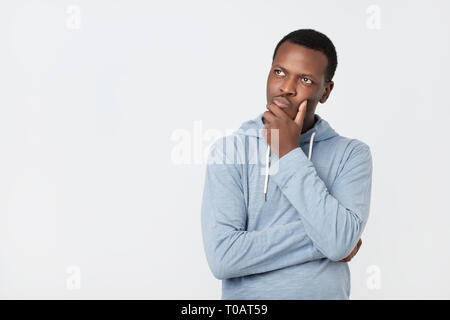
[201,114,372,299]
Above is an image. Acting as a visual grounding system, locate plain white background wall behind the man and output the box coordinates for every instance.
[0,0,450,299]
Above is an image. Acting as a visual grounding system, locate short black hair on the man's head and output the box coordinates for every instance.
[272,29,337,82]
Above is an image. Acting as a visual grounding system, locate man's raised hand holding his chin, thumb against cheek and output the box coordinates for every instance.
[263,100,307,158]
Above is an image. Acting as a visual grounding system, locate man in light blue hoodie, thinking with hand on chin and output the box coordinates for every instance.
[201,29,372,299]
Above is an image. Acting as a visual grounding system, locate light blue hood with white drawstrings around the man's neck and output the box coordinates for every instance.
[236,113,338,201]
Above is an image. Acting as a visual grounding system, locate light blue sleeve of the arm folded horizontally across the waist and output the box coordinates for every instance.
[201,138,324,279]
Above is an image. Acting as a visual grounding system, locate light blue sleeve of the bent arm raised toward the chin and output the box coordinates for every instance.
[271,139,372,261]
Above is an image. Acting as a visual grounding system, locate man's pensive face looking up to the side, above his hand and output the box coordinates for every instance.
[267,41,333,119]
